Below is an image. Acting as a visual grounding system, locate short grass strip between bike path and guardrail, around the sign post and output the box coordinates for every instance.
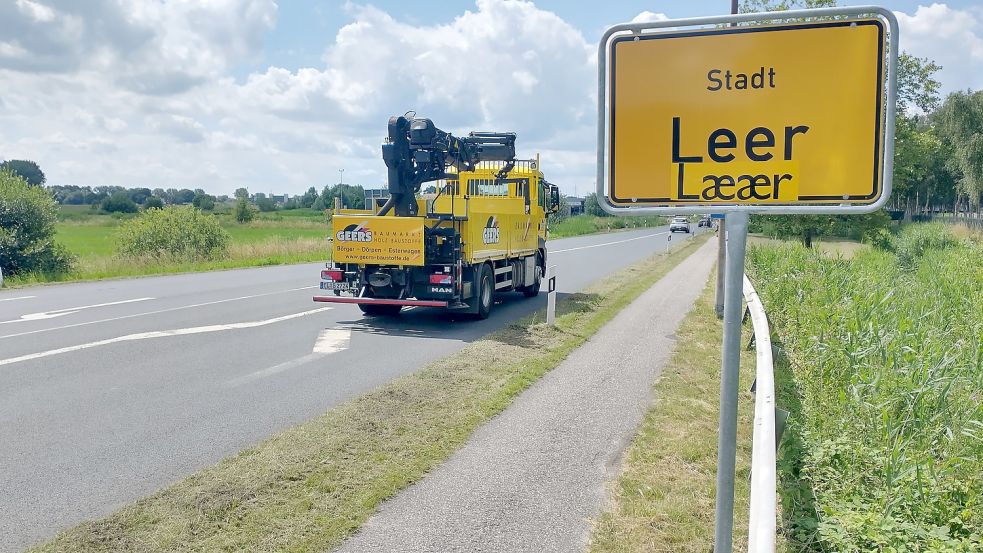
[590,277,754,553]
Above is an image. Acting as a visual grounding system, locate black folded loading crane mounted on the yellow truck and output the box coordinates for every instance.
[379,115,515,217]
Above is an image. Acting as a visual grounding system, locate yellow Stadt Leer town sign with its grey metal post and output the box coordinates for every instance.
[597,6,898,553]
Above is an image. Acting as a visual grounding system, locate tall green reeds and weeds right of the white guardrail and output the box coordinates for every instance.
[748,224,983,552]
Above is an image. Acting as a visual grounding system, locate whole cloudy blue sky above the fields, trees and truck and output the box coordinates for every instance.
[0,0,983,194]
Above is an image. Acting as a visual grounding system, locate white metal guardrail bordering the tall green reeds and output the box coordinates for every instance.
[744,275,778,553]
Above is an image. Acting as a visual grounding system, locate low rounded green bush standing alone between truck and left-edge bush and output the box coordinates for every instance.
[117,206,229,261]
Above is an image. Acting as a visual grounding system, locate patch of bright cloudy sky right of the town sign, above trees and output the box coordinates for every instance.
[895,4,983,94]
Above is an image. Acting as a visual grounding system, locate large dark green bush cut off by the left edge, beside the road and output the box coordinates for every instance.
[0,170,74,276]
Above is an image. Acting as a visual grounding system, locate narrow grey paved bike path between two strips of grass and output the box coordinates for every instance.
[339,242,716,553]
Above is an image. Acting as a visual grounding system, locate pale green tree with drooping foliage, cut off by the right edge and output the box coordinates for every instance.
[938,90,983,209]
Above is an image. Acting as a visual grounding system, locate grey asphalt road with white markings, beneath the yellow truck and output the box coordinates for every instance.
[0,223,708,551]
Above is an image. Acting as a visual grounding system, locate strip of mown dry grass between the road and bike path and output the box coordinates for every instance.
[31,237,706,552]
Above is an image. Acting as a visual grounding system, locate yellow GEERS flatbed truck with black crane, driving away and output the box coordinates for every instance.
[314,115,559,319]
